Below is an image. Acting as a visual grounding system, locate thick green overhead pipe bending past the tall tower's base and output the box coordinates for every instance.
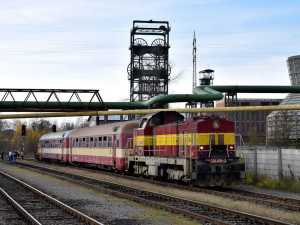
[0,85,300,112]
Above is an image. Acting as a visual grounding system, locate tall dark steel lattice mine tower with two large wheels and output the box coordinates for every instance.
[127,20,171,102]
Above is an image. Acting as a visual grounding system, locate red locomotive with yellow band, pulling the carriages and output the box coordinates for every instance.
[128,112,245,186]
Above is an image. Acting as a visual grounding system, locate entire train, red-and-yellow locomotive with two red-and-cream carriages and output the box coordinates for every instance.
[37,111,245,186]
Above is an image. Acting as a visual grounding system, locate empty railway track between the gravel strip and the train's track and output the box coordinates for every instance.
[10,163,288,225]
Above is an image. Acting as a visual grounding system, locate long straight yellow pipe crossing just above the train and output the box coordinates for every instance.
[0,105,300,119]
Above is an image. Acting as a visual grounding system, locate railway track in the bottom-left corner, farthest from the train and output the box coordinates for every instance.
[0,171,102,225]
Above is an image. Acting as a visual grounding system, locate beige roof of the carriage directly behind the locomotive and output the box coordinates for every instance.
[70,120,140,137]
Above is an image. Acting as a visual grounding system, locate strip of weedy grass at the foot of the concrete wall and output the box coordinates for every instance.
[243,173,300,193]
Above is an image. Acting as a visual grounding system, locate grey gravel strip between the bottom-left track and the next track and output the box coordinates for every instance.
[0,162,197,225]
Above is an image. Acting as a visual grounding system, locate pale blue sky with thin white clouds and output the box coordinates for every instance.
[0,0,300,106]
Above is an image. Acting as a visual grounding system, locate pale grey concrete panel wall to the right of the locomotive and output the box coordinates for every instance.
[246,147,300,179]
